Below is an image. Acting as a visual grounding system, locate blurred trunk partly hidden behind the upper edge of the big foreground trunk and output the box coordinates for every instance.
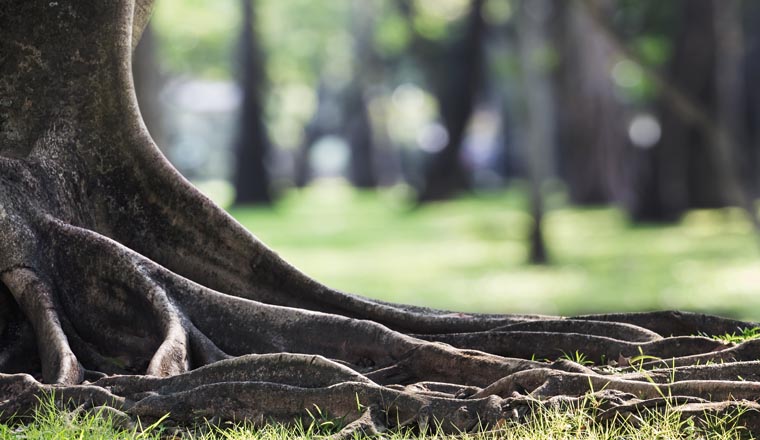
[132,25,167,155]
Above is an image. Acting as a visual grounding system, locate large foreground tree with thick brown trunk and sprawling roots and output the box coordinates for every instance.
[0,0,760,437]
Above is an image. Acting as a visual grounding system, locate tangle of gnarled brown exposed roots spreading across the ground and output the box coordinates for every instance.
[0,217,760,438]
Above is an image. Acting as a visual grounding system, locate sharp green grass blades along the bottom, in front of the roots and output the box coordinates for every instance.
[0,397,752,440]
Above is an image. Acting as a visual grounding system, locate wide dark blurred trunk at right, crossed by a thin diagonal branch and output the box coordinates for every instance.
[629,0,725,222]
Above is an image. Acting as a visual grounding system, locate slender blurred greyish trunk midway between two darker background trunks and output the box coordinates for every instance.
[343,0,379,188]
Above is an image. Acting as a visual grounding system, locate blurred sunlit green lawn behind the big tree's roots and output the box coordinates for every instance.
[226,180,760,320]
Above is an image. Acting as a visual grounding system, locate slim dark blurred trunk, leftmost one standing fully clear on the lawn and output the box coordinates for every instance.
[235,0,272,204]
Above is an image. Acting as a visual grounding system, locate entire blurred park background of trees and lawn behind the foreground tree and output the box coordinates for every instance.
[134,0,760,320]
